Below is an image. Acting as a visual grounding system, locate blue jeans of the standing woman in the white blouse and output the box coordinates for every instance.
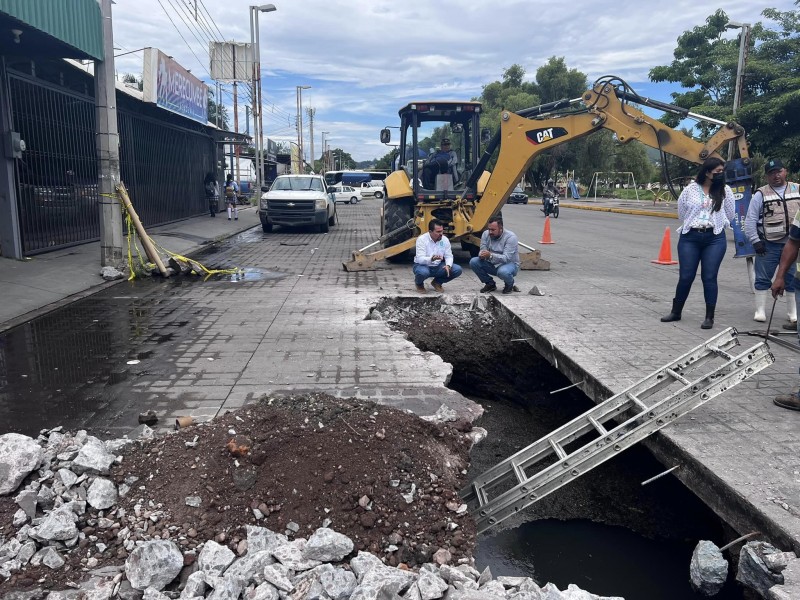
[675,229,728,306]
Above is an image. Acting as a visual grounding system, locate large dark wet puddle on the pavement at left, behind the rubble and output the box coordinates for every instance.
[0,280,212,436]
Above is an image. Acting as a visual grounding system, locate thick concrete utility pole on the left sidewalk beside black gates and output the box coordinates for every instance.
[94,0,122,268]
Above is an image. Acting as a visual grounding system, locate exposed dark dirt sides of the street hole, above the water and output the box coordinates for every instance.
[376,296,723,540]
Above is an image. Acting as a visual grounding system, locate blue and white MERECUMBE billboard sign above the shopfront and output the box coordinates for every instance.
[142,48,208,125]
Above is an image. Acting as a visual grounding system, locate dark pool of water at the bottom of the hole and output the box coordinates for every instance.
[475,519,744,600]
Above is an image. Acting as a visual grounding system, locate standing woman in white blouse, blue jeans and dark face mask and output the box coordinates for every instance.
[661,157,735,329]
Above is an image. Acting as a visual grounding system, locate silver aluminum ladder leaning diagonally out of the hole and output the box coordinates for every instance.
[461,327,775,533]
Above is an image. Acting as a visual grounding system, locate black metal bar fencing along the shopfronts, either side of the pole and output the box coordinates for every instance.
[9,67,216,255]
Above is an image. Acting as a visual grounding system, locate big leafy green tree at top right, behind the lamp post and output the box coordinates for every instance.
[650,5,800,170]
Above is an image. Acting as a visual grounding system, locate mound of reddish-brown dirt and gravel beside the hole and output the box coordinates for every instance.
[0,394,475,593]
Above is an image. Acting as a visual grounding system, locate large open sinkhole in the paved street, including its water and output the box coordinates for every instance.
[370,296,748,600]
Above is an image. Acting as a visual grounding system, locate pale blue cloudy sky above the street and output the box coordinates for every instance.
[113,0,796,161]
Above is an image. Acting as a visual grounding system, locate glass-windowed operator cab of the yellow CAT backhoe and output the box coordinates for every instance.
[381,100,481,200]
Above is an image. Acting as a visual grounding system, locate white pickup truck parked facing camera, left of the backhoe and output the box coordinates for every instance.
[258,175,336,233]
